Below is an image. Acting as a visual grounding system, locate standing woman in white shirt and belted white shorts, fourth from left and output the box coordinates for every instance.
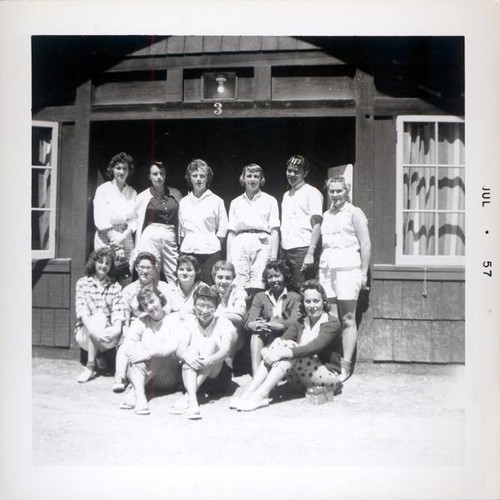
[227,163,280,297]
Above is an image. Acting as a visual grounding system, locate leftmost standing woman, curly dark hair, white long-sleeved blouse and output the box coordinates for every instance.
[94,153,137,270]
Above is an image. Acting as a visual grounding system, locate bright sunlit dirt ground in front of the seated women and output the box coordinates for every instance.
[32,349,465,466]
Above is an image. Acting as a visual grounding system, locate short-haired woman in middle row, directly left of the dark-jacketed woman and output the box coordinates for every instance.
[212,260,248,360]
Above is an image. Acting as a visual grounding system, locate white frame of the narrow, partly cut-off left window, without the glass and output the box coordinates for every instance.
[30,120,59,260]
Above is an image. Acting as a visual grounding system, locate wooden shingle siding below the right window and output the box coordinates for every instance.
[358,280,465,363]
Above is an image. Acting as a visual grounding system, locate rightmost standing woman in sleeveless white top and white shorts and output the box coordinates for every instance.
[319,177,371,382]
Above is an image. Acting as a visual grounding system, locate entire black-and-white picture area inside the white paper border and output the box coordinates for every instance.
[31,36,466,466]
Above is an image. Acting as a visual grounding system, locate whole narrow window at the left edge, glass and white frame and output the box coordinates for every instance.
[31,121,58,259]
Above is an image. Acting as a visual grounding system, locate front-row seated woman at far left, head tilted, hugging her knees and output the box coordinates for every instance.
[120,287,181,415]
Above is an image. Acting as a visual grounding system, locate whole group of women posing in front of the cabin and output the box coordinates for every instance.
[75,153,370,419]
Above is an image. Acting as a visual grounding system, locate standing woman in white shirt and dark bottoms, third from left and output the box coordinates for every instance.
[179,160,227,285]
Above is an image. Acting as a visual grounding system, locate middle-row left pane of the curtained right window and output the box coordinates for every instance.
[403,167,436,210]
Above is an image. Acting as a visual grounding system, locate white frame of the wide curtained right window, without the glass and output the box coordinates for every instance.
[395,115,467,267]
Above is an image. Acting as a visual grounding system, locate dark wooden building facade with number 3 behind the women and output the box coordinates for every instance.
[32,36,465,363]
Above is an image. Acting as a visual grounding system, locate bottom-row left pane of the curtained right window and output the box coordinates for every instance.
[403,212,436,255]
